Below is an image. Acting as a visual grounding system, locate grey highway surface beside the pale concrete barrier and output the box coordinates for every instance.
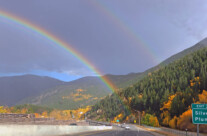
[67,125,153,136]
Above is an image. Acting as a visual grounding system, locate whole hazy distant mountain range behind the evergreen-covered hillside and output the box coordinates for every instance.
[0,39,207,109]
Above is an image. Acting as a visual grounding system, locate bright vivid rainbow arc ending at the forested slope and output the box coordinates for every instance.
[0,10,117,92]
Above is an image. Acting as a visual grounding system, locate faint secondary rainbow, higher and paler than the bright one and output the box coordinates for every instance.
[89,0,160,65]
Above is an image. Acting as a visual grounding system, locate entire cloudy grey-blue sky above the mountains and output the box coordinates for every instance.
[0,0,207,81]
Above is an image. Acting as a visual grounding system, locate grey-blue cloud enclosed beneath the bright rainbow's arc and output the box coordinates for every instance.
[0,24,89,75]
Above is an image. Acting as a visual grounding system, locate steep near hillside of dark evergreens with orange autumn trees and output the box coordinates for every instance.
[90,48,207,130]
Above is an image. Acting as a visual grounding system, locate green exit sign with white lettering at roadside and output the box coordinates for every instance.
[192,104,207,124]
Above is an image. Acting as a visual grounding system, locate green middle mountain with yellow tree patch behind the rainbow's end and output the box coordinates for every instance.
[19,73,141,109]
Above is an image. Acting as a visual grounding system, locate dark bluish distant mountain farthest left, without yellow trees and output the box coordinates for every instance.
[0,75,64,106]
